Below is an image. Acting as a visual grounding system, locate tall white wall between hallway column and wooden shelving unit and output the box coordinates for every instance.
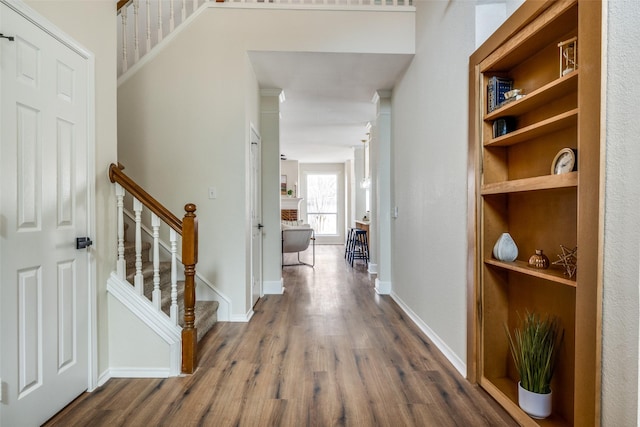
[391,1,475,371]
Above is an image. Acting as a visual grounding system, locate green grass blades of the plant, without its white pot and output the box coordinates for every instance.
[505,312,564,394]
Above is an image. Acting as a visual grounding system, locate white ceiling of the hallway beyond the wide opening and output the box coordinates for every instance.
[249,52,413,163]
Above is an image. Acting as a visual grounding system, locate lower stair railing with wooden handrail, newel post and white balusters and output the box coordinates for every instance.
[109,163,198,374]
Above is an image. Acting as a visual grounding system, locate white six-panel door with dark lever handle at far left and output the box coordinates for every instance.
[0,3,90,427]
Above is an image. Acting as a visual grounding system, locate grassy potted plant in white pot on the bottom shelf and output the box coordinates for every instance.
[505,312,564,419]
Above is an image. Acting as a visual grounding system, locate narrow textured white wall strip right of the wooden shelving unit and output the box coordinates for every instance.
[602,0,640,426]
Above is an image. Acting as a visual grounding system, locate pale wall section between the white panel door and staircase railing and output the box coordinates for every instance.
[25,0,117,382]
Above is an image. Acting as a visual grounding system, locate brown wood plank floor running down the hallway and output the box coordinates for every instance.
[46,246,516,427]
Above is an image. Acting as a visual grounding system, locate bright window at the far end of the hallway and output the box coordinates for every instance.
[307,174,338,236]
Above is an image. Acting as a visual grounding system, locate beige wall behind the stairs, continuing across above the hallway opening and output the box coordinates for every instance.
[118,3,414,319]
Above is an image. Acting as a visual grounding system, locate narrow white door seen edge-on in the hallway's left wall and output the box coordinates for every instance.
[250,127,262,307]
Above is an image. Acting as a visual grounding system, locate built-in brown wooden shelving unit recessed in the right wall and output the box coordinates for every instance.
[468,0,602,427]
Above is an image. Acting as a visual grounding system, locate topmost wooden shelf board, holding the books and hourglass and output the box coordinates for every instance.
[484,70,580,121]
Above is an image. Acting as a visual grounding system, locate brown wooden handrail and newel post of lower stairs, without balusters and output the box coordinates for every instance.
[109,163,198,374]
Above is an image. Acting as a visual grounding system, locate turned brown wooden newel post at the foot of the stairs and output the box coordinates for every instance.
[182,203,198,374]
